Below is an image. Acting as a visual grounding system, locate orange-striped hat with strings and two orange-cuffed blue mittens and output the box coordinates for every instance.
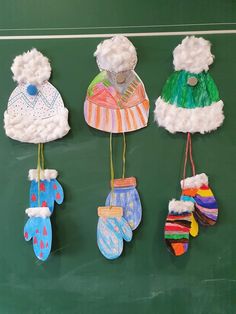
[84,35,149,259]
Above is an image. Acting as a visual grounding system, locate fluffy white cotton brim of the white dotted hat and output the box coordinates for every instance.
[4,108,70,144]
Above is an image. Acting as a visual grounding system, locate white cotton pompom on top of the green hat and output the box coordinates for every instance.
[173,36,214,74]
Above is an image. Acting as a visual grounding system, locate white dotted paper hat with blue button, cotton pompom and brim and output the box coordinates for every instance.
[4,49,70,144]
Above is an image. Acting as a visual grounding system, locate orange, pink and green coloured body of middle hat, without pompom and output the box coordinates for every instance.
[84,71,149,133]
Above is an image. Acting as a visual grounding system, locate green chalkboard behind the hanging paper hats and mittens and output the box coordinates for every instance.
[0,0,236,314]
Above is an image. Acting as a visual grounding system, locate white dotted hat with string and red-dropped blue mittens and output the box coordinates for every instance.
[4,49,70,261]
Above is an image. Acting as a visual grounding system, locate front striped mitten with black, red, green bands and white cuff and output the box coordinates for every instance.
[165,199,194,256]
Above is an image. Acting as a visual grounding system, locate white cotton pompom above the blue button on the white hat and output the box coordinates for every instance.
[11,48,51,85]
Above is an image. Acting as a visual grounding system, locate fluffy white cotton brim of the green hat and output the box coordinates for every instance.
[154,97,224,134]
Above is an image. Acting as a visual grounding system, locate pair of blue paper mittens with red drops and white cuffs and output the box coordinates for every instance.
[24,169,64,261]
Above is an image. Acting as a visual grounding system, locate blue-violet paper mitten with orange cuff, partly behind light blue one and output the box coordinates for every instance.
[106,177,142,230]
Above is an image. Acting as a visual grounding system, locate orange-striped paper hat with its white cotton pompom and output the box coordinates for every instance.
[84,35,149,133]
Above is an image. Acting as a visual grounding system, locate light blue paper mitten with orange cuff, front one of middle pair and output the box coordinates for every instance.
[97,207,132,259]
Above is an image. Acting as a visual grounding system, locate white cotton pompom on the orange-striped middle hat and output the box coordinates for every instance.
[94,35,137,73]
